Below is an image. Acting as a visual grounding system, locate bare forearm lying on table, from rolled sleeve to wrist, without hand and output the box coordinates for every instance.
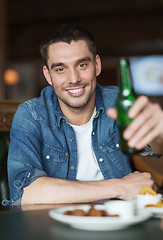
[21,177,120,205]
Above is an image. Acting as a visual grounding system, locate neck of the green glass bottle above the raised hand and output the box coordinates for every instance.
[119,58,133,96]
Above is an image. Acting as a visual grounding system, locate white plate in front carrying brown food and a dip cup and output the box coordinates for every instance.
[49,205,152,231]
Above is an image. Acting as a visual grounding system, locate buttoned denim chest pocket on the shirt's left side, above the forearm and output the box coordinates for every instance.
[42,145,68,179]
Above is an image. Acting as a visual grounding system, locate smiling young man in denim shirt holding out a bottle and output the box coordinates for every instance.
[4,25,163,205]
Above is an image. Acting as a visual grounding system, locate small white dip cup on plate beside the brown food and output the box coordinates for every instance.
[105,200,136,220]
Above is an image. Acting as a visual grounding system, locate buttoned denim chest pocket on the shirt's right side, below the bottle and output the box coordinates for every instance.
[100,132,129,171]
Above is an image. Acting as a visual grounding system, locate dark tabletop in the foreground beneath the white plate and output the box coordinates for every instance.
[0,205,163,240]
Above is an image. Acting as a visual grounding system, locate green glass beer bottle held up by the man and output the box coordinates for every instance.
[116,58,139,155]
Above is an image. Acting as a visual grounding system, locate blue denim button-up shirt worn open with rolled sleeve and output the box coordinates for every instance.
[3,85,154,205]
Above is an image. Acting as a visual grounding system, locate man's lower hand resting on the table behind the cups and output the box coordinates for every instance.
[120,171,154,200]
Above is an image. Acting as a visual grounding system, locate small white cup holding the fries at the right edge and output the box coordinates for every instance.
[137,194,162,209]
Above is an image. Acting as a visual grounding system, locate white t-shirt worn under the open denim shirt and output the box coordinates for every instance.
[71,109,104,181]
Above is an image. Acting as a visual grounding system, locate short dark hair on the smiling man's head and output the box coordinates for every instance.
[40,24,97,67]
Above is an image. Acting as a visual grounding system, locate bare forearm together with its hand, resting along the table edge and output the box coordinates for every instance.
[21,172,154,205]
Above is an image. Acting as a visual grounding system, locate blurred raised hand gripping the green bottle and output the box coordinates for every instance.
[107,96,163,154]
